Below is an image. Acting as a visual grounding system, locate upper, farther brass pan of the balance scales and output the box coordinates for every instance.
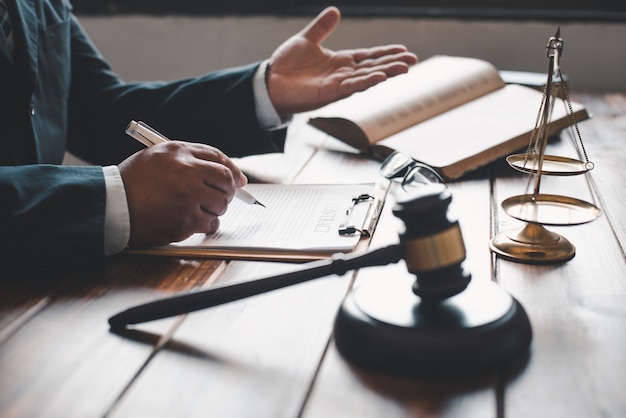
[506,154,593,176]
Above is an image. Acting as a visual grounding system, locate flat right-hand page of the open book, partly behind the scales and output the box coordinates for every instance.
[379,84,585,179]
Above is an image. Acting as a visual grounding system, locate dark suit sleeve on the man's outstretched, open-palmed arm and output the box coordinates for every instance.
[68,16,285,165]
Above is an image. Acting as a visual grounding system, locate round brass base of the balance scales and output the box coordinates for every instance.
[489,223,576,264]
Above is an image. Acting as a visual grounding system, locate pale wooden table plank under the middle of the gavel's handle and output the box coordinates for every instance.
[105,122,377,418]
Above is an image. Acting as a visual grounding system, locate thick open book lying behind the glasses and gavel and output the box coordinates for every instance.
[309,55,589,180]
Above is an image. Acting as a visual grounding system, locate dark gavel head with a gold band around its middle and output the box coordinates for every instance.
[393,184,471,302]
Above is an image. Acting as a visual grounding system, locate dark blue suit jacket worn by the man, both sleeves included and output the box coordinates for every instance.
[0,0,285,268]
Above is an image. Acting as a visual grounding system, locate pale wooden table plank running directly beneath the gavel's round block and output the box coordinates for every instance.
[303,173,499,418]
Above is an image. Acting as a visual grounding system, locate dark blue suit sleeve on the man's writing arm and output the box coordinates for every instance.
[0,165,106,270]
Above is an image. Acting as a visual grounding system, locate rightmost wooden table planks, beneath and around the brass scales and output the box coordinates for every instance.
[495,94,626,417]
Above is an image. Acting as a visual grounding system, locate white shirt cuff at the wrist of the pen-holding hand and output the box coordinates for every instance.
[102,165,130,256]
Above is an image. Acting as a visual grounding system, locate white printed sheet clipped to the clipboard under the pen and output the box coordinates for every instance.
[159,184,374,253]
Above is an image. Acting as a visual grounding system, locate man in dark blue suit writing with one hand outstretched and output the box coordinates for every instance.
[0,0,417,270]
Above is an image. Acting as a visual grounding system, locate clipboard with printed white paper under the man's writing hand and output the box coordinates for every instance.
[129,184,384,261]
